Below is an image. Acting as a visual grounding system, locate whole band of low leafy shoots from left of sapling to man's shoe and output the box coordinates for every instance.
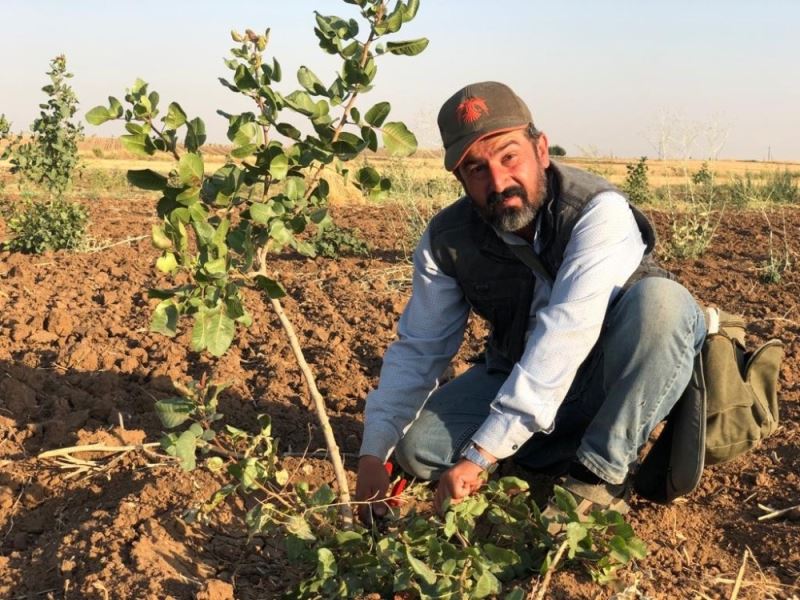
[156,381,646,599]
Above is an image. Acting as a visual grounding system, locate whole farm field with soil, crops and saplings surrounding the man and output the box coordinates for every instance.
[0,0,800,600]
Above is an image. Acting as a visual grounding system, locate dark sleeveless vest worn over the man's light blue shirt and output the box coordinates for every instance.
[430,162,669,371]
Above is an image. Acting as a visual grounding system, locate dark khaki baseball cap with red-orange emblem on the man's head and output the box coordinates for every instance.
[438,81,533,171]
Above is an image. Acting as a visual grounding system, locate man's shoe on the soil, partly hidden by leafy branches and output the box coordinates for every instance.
[542,475,631,535]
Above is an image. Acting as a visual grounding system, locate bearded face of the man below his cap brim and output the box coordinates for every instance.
[458,129,550,232]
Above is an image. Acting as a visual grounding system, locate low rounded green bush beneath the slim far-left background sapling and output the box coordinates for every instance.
[8,198,88,254]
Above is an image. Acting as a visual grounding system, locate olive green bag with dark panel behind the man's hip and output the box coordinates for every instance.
[634,308,783,502]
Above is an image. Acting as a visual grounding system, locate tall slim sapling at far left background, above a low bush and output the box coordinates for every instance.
[0,55,83,196]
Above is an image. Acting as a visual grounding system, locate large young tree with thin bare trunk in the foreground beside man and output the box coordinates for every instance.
[86,0,428,519]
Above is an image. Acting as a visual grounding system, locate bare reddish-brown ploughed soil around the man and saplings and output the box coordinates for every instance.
[0,199,800,600]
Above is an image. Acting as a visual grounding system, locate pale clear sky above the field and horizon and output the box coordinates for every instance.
[0,0,800,160]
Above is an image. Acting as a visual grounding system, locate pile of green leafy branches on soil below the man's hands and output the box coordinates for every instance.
[287,477,646,600]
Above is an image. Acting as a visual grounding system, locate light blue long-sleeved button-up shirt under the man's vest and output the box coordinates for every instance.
[360,192,645,460]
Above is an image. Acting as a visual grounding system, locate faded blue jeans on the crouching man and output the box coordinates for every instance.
[395,277,706,484]
